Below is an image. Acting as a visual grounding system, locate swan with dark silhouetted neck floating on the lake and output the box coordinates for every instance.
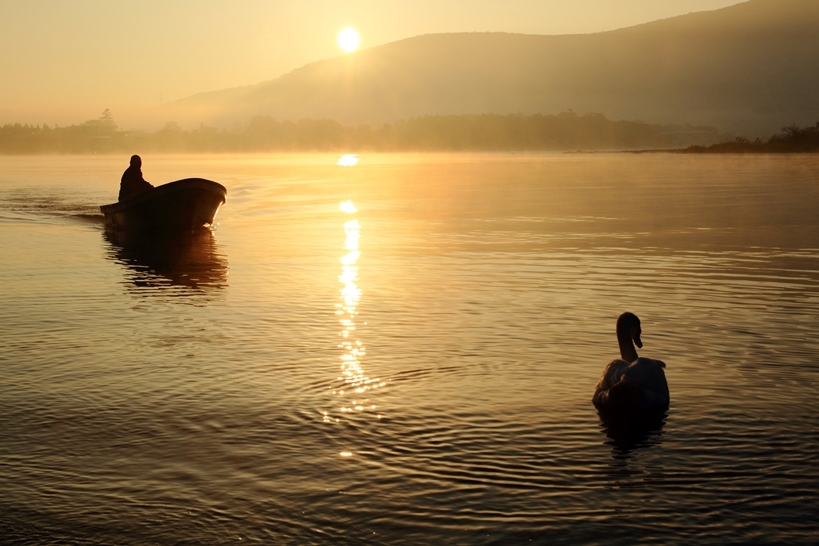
[592,313,670,417]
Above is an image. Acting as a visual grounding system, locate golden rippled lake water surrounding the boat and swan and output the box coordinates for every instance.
[0,154,819,545]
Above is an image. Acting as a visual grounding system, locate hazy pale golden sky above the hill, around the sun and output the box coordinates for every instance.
[0,0,740,126]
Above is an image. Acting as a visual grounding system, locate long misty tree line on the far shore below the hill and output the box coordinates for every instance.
[0,109,727,155]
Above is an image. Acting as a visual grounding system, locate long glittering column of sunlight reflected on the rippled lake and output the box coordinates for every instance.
[322,197,385,422]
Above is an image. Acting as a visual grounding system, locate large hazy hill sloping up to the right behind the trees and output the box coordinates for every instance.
[163,0,819,136]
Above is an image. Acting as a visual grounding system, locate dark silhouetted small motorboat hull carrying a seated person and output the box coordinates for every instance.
[100,178,227,234]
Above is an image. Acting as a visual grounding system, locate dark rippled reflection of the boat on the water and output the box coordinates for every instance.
[103,231,228,296]
